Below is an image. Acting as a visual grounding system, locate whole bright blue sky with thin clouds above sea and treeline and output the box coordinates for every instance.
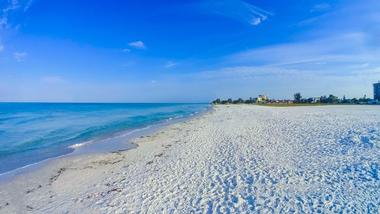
[0,0,380,102]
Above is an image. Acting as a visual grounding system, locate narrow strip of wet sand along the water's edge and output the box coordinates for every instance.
[0,106,213,181]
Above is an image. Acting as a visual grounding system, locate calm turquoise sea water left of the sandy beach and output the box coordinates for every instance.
[0,103,209,174]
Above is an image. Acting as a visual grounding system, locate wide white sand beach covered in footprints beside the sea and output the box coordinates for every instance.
[0,105,380,213]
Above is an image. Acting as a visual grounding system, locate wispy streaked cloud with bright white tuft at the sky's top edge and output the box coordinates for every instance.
[199,0,274,26]
